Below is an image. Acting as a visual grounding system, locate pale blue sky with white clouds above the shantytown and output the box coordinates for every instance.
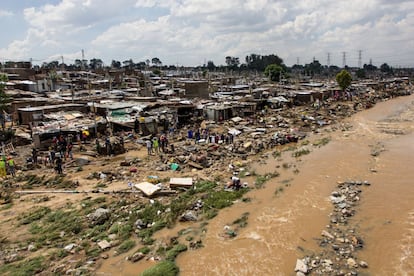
[0,0,414,67]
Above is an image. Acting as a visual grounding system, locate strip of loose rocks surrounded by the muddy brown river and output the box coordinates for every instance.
[295,181,371,275]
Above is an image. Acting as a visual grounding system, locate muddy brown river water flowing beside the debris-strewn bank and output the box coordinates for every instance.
[97,95,414,275]
